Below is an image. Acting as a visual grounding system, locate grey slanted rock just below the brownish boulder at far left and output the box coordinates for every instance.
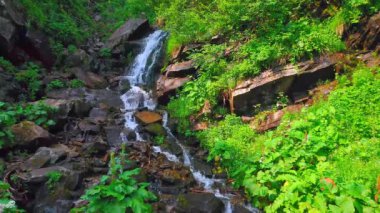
[23,147,68,170]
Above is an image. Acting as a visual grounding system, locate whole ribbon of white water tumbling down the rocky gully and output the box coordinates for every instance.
[121,30,258,213]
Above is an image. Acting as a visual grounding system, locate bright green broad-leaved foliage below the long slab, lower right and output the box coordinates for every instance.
[198,67,380,212]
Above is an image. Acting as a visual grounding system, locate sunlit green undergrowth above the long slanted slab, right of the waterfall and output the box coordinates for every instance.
[163,0,380,131]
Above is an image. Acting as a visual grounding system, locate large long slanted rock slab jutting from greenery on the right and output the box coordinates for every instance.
[230,56,336,115]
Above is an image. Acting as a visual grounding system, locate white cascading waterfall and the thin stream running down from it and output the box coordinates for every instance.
[121,30,253,213]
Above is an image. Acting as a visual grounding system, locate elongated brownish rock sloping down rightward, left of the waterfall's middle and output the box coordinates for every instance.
[69,67,108,89]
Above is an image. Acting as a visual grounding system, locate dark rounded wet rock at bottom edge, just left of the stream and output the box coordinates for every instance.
[175,193,224,213]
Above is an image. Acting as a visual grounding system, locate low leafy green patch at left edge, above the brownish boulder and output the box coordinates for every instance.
[0,102,56,148]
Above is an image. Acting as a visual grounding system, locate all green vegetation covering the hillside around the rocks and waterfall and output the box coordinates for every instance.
[0,0,380,213]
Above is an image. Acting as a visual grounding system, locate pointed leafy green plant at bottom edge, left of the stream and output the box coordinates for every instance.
[74,145,156,213]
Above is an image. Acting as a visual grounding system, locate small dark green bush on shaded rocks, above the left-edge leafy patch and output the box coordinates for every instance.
[16,62,42,100]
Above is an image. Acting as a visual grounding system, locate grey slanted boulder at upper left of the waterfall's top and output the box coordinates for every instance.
[105,19,150,49]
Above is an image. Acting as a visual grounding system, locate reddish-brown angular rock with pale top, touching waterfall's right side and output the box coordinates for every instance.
[156,75,191,104]
